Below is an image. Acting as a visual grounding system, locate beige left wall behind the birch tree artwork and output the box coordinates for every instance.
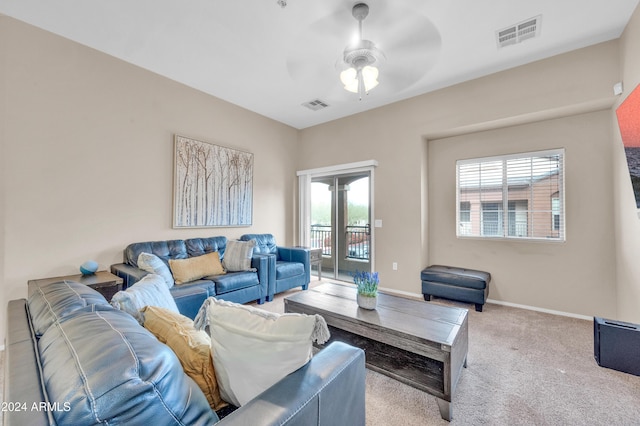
[0,17,298,339]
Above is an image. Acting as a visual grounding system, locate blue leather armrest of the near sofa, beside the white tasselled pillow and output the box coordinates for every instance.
[218,342,365,426]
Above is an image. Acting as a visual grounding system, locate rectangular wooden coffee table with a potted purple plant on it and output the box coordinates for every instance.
[284,284,469,420]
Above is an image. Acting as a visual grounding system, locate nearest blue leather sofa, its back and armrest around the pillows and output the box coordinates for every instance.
[3,282,365,426]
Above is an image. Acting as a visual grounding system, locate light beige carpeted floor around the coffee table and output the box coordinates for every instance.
[252,282,640,426]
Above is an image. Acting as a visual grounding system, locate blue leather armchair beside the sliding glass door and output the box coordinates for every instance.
[240,234,311,302]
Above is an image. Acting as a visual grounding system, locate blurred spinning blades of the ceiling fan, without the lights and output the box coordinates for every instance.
[287,0,441,103]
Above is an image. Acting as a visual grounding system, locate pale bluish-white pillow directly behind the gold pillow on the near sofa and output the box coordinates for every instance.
[111,274,179,324]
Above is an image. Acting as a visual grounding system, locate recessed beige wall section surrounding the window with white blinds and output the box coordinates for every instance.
[428,110,616,316]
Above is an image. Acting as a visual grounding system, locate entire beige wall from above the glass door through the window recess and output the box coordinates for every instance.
[299,41,619,316]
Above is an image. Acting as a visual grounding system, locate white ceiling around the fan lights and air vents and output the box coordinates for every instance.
[0,0,640,129]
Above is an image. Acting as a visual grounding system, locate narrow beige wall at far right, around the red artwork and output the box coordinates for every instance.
[612,4,640,323]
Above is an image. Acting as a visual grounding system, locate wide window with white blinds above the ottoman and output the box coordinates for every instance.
[456,149,565,241]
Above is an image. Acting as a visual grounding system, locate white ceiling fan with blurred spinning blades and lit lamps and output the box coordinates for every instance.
[286,0,441,104]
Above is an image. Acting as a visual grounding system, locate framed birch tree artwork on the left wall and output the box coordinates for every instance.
[173,135,253,228]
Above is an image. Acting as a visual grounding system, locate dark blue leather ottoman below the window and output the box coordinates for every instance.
[420,265,491,312]
